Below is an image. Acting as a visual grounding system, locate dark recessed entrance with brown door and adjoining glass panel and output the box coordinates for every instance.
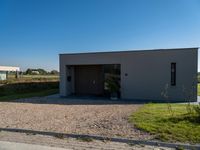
[74,64,121,97]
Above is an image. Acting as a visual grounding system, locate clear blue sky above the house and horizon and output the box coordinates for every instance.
[0,0,200,70]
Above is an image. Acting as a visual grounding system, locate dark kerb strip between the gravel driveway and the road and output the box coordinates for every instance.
[0,128,200,150]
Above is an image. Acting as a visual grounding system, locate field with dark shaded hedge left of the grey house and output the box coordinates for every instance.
[0,75,59,101]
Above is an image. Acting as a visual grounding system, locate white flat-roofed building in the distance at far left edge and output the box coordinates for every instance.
[0,66,20,80]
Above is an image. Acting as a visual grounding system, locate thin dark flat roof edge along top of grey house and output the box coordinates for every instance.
[59,47,199,55]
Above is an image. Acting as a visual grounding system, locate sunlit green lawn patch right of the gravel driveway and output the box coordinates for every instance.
[129,104,200,143]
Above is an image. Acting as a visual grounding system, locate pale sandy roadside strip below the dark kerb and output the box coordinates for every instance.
[0,131,174,150]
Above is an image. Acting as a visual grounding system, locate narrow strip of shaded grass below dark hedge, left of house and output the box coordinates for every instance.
[0,89,58,101]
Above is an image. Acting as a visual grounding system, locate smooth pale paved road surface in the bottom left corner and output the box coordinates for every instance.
[0,141,72,150]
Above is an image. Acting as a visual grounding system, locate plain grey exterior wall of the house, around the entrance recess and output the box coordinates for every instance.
[60,48,198,102]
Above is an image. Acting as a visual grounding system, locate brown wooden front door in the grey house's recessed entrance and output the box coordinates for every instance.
[75,65,104,95]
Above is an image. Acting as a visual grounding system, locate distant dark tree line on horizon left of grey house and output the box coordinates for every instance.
[24,68,59,75]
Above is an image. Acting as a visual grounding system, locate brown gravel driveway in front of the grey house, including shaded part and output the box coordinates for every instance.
[0,97,151,139]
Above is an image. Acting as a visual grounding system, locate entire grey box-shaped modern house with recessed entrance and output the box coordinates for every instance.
[60,48,198,102]
